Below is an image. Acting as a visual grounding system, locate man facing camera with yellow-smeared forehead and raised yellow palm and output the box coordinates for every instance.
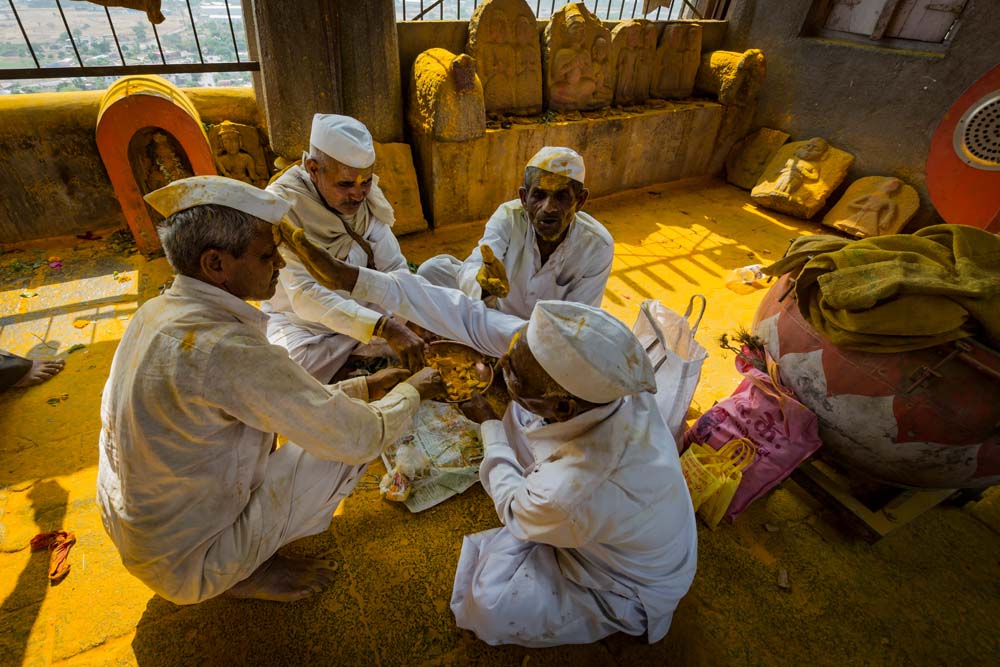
[418,146,614,318]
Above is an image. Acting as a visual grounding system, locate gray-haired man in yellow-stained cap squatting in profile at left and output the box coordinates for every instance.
[97,176,441,604]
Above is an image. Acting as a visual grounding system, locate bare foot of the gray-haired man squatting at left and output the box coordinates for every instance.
[225,554,337,602]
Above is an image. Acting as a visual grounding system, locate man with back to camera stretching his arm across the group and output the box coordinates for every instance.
[274,227,697,647]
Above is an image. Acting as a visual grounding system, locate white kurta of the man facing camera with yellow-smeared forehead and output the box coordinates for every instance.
[418,199,614,319]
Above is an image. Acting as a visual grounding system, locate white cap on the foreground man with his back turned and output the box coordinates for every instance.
[525,301,656,403]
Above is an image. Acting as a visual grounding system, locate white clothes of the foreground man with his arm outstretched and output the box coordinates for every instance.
[353,271,697,646]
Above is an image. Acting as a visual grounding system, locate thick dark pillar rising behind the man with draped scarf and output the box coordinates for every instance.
[253,0,403,159]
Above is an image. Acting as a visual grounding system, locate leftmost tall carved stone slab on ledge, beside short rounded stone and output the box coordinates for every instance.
[466,0,542,115]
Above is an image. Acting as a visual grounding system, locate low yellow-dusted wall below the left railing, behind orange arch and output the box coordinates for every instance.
[0,88,260,243]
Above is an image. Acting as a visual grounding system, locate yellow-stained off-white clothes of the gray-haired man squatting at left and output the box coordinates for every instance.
[97,276,420,604]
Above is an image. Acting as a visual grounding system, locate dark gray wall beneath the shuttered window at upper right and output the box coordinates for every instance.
[725,0,1000,229]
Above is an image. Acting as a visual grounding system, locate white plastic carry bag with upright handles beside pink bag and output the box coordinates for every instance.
[632,294,708,445]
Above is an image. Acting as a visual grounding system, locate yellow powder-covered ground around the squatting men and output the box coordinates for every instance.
[0,182,1000,666]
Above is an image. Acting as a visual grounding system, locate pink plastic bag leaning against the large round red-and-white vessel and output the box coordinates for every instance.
[684,358,823,521]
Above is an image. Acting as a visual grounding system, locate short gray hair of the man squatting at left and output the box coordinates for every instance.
[157,204,262,276]
